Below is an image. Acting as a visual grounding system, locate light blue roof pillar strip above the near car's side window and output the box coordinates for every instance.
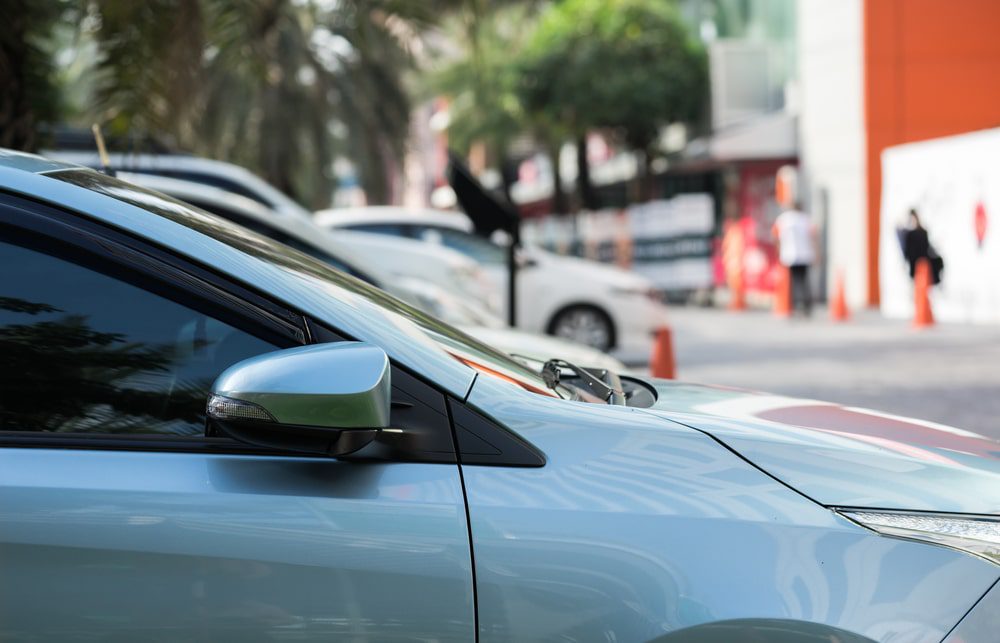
[0,165,475,398]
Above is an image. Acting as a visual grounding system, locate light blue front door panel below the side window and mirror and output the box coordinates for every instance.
[0,448,474,641]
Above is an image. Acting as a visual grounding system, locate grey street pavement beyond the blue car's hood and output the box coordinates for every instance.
[670,307,1000,439]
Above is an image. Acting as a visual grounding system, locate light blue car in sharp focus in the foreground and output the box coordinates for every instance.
[0,152,1000,643]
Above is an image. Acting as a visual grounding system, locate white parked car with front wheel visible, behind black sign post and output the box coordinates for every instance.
[316,207,666,359]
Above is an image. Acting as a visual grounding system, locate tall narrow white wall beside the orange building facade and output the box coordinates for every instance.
[796,0,868,308]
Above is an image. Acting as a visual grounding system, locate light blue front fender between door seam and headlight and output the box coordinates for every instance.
[462,375,1000,643]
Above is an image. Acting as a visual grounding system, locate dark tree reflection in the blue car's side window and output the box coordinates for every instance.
[0,297,210,434]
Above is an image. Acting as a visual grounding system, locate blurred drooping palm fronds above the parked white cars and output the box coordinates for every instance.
[89,0,452,207]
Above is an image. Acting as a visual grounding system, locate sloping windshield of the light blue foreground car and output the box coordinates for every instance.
[46,169,585,399]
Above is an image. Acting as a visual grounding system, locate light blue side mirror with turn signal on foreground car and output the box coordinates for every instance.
[208,342,391,456]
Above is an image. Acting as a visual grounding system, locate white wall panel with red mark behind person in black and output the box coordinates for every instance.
[879,129,1000,323]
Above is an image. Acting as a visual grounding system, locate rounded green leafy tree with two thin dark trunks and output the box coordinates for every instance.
[520,0,708,201]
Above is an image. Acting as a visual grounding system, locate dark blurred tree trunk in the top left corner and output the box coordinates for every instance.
[0,0,69,151]
